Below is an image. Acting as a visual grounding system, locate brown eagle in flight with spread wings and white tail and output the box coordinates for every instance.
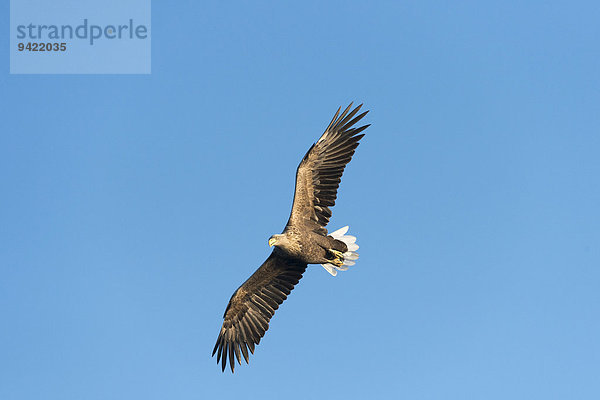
[212,103,369,372]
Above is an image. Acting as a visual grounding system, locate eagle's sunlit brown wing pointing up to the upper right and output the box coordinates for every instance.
[287,103,369,233]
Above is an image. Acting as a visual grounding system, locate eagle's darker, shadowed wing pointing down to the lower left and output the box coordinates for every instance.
[212,253,306,372]
